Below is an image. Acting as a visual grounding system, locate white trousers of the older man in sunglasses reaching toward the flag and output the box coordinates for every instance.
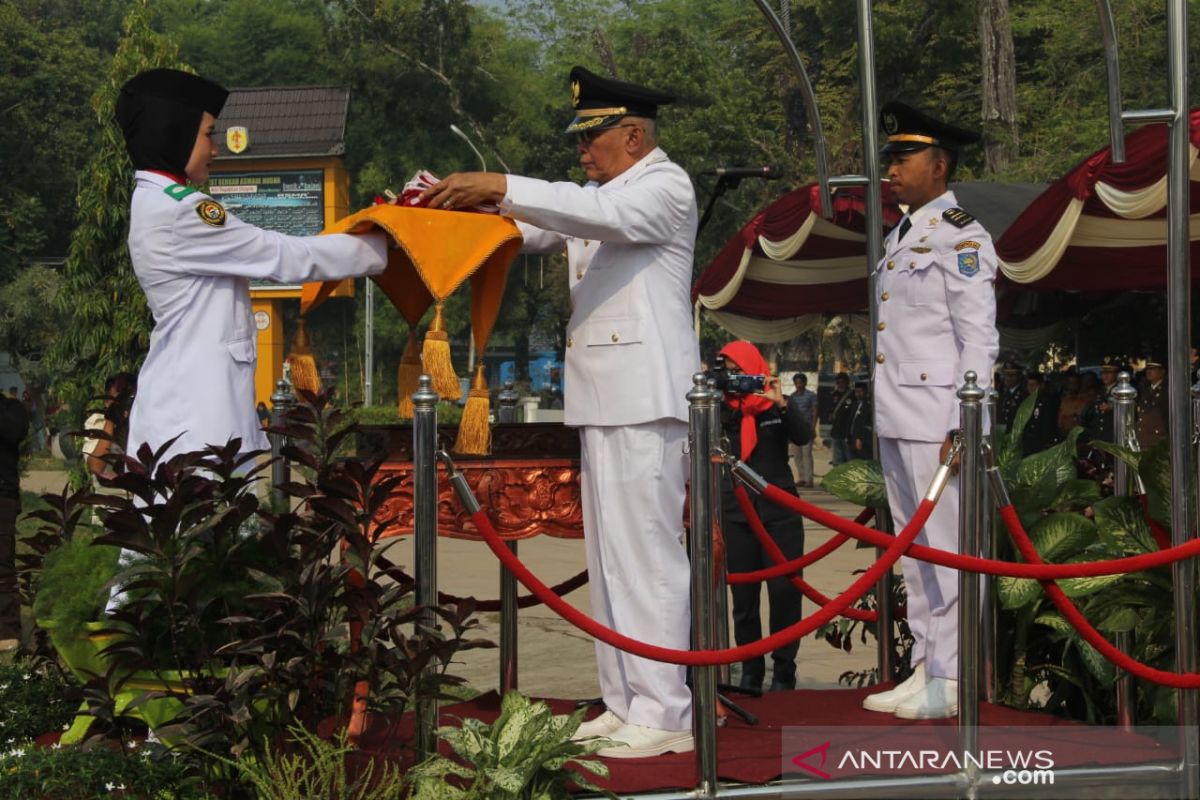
[580,420,691,730]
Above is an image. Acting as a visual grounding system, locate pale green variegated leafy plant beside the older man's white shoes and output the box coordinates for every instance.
[407,692,616,800]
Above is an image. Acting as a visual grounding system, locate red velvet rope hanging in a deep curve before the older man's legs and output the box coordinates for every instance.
[460,500,934,667]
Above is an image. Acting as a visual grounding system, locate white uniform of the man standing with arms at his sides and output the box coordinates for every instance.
[875,192,1000,680]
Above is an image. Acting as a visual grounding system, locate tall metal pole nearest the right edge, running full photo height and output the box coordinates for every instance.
[1166,0,1200,798]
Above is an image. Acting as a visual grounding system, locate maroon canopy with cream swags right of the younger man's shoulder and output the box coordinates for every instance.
[996,110,1200,291]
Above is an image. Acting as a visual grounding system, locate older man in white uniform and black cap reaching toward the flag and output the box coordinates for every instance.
[424,67,700,758]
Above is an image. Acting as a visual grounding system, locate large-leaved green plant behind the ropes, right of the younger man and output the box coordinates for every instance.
[994,398,1175,724]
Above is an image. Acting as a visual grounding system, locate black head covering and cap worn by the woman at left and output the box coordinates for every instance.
[116,70,229,174]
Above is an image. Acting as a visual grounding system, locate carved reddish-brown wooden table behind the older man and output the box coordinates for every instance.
[359,422,583,540]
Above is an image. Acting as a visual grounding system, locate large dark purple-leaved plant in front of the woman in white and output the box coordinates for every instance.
[70,395,491,786]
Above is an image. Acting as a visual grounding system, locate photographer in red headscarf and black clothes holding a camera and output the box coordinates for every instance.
[714,342,812,692]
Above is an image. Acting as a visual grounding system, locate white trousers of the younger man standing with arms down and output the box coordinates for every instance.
[880,438,959,680]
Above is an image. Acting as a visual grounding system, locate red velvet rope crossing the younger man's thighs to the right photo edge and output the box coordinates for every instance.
[762,486,1200,581]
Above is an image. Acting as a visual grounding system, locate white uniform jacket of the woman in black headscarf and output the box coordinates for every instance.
[126,170,388,456]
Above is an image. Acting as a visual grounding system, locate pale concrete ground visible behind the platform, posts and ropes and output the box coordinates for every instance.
[22,445,892,698]
